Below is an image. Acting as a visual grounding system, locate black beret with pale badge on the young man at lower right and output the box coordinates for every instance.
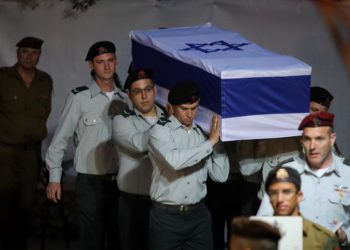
[265,166,301,192]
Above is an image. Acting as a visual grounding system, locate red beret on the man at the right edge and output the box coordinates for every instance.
[298,112,334,130]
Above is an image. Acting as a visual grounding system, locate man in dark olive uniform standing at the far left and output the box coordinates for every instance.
[0,37,52,249]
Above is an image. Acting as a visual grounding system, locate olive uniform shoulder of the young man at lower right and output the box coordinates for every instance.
[303,217,340,250]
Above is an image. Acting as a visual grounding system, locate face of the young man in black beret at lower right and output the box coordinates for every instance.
[268,182,303,216]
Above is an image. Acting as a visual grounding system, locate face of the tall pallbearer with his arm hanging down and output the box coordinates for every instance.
[89,53,117,82]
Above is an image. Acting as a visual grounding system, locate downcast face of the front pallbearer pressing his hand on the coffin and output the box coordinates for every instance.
[172,100,199,128]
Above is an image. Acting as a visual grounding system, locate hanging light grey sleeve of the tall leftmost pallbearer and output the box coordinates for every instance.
[45,93,80,182]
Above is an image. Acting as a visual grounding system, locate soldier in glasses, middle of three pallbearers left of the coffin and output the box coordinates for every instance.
[113,69,166,250]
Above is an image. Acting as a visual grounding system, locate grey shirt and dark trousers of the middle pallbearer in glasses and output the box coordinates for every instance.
[113,103,166,249]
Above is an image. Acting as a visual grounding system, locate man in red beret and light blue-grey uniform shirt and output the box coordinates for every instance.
[258,112,350,247]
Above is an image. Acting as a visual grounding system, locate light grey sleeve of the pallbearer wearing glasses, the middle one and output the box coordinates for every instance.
[113,115,149,153]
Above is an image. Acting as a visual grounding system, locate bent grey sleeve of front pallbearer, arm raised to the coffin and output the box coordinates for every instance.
[148,124,213,171]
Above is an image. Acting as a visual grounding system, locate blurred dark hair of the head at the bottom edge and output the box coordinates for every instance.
[231,216,281,250]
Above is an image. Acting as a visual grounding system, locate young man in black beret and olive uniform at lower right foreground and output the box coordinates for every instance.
[265,166,339,250]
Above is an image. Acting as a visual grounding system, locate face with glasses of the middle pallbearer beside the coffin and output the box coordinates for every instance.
[129,79,157,116]
